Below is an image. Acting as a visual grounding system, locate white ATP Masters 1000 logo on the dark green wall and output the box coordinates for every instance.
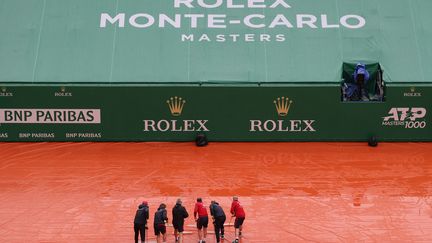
[382,107,427,128]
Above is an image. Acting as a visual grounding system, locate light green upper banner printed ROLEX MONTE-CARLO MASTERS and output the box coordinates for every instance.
[0,0,432,83]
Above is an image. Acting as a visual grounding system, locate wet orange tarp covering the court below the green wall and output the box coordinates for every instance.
[0,143,432,243]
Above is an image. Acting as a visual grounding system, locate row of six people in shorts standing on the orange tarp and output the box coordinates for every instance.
[134,196,246,243]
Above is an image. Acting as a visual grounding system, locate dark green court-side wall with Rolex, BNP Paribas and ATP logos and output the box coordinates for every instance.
[0,85,432,141]
